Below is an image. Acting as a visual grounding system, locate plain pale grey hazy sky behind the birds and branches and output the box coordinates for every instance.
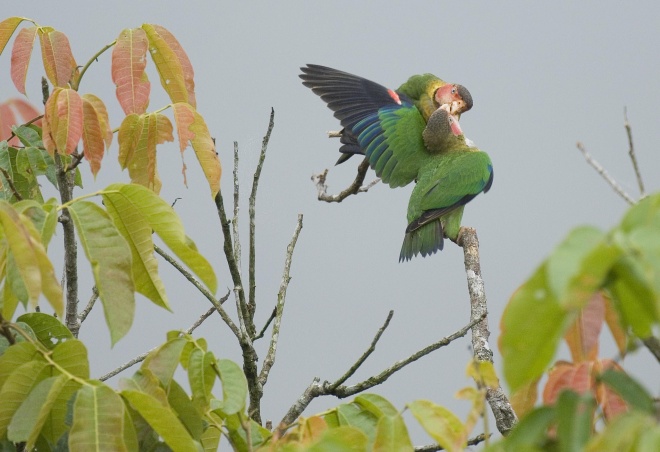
[0,1,660,444]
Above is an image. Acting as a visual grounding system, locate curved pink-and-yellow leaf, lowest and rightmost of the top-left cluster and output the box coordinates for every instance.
[173,103,222,198]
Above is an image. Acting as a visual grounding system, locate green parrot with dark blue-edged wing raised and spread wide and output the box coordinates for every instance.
[300,64,472,187]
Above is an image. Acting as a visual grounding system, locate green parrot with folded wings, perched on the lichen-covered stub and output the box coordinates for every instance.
[399,106,493,262]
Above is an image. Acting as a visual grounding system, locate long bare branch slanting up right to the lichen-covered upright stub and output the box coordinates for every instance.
[276,316,485,435]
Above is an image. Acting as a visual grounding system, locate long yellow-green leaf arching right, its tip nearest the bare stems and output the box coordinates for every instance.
[103,184,217,293]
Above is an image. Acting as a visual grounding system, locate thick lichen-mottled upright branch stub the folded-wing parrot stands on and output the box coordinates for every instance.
[458,227,518,435]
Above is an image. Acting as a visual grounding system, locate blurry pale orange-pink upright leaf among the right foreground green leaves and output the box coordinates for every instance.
[564,292,605,363]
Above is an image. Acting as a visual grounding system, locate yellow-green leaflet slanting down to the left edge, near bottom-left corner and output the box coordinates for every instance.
[0,360,47,438]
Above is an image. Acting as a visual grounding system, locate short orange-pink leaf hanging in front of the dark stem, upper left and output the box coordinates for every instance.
[44,88,83,154]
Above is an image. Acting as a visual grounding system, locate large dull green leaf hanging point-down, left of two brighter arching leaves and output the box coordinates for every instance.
[69,200,135,345]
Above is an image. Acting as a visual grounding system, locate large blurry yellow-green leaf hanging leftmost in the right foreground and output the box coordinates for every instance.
[500,264,572,391]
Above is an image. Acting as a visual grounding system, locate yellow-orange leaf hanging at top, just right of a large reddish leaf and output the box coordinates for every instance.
[142,24,188,103]
